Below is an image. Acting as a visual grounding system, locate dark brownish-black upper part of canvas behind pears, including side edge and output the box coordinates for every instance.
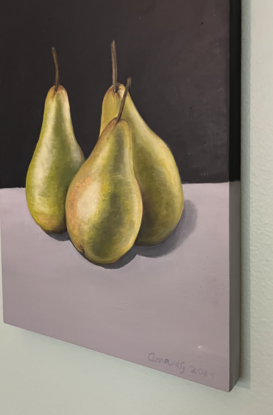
[0,0,240,187]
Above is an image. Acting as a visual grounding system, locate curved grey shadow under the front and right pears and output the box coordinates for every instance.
[103,200,197,269]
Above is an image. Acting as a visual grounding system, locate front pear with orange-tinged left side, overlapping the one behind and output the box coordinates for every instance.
[66,82,142,265]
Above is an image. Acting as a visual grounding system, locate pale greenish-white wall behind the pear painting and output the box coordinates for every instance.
[0,0,273,415]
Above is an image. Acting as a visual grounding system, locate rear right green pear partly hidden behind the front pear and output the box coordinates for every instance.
[101,42,184,246]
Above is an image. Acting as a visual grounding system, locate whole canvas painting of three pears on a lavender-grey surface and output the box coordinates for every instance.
[0,0,241,391]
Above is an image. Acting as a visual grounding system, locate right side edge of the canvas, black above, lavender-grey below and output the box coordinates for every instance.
[228,0,242,392]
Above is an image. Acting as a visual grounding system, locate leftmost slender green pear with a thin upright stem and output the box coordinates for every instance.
[26,48,85,234]
